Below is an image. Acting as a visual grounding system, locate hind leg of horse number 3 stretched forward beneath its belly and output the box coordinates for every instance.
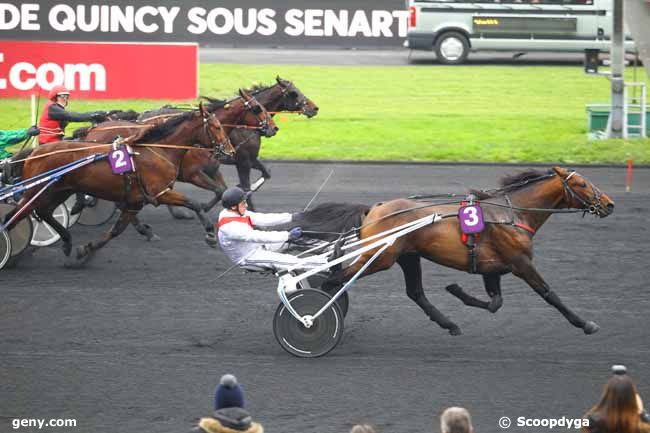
[397,254,462,335]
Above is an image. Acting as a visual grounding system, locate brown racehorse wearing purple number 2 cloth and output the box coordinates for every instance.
[4,106,234,267]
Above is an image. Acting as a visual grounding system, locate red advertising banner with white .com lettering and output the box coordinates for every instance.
[0,41,198,99]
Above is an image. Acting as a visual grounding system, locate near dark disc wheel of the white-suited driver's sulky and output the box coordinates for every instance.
[273,289,343,358]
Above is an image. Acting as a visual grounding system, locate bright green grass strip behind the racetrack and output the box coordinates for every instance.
[0,64,650,164]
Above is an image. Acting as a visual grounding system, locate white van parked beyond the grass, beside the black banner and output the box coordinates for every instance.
[405,0,634,64]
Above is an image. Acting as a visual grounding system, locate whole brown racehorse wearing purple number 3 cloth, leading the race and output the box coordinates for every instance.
[292,167,614,335]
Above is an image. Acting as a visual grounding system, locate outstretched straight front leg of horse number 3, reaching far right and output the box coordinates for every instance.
[512,255,600,334]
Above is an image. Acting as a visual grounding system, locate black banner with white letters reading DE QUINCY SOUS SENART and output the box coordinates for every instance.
[0,0,408,48]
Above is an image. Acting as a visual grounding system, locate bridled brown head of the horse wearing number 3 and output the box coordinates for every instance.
[553,167,614,218]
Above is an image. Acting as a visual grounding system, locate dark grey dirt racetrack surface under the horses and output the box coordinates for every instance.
[0,163,650,433]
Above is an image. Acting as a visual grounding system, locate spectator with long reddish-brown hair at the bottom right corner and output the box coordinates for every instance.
[585,366,643,433]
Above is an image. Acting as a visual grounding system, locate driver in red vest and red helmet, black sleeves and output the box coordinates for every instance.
[38,86,107,144]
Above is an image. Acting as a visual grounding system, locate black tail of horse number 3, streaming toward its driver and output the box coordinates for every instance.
[274,203,370,240]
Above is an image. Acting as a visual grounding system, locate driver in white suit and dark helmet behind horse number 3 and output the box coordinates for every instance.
[217,187,327,269]
